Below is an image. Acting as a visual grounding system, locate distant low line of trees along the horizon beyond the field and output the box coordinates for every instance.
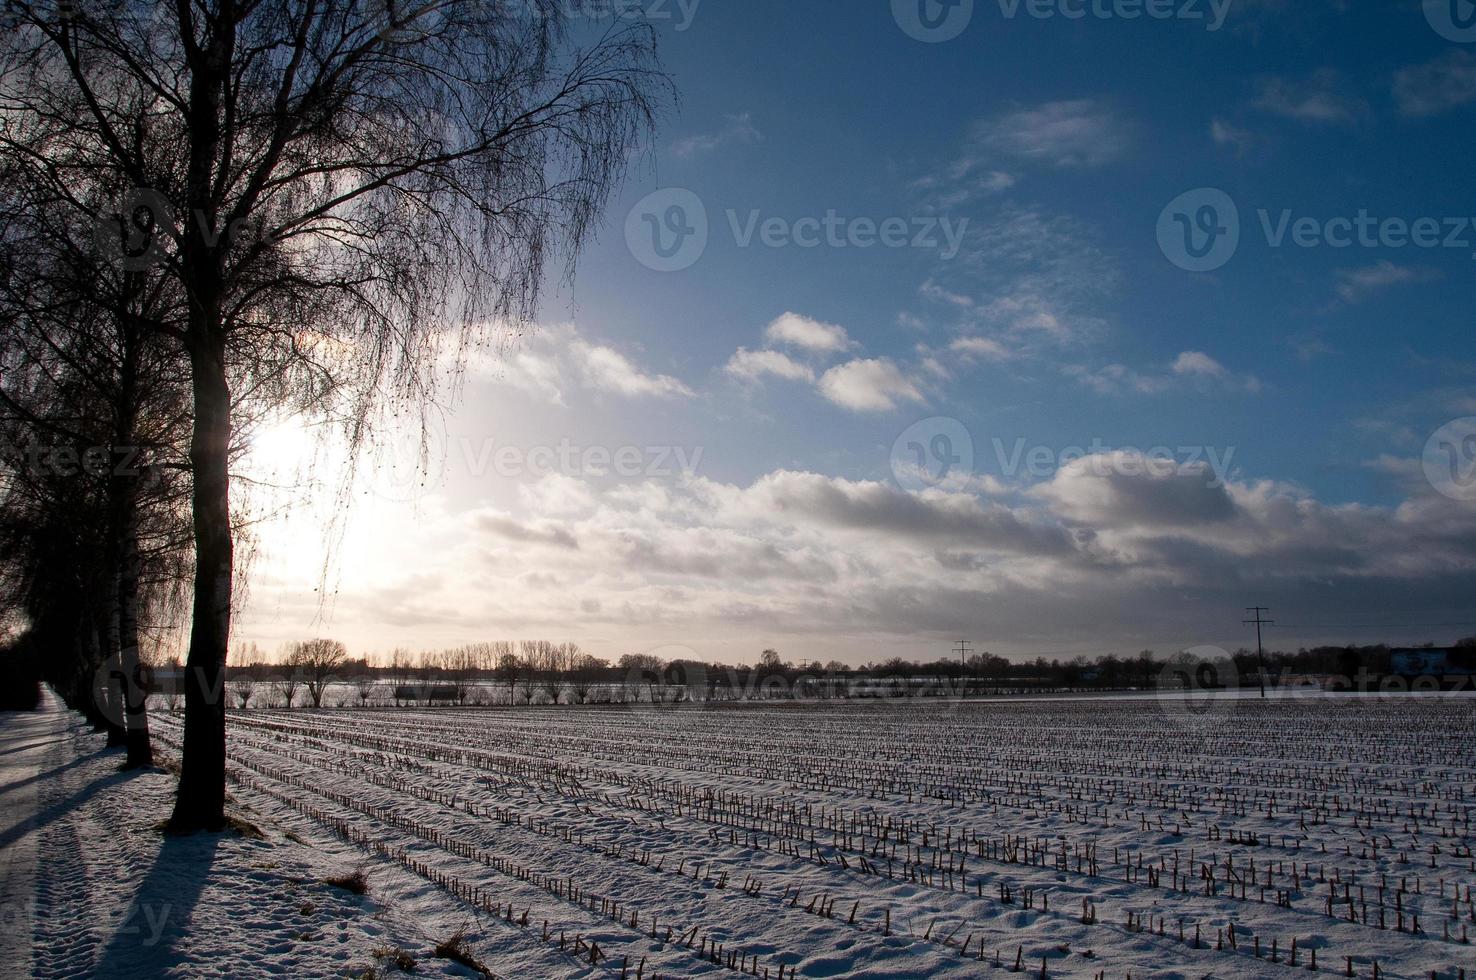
[164,638,1476,708]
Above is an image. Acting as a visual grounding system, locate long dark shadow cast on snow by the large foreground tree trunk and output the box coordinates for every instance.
[93,831,219,977]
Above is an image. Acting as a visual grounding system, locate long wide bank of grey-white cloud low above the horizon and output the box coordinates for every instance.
[242,450,1476,660]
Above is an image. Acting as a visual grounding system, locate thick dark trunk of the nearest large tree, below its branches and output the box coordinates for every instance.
[170,329,235,832]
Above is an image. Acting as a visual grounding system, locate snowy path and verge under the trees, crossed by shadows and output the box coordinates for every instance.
[0,692,466,980]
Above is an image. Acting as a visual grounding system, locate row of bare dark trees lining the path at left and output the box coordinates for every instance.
[0,0,669,831]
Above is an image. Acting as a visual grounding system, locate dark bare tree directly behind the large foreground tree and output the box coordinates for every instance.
[0,180,189,767]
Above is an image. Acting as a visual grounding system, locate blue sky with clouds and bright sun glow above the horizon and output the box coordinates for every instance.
[236,0,1476,663]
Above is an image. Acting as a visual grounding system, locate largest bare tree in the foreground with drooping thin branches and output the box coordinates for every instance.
[0,0,667,829]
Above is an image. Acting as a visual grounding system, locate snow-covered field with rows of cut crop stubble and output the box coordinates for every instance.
[0,695,1476,979]
